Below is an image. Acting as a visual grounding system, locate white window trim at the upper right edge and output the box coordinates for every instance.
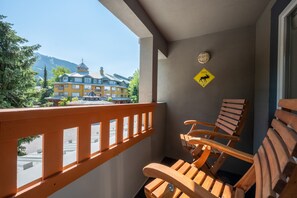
[276,0,297,104]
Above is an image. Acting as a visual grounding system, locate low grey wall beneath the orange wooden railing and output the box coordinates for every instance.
[50,104,166,198]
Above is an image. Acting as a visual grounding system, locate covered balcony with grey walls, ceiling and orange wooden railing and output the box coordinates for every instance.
[0,0,297,198]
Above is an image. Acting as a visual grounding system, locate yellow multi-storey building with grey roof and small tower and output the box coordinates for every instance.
[48,61,130,103]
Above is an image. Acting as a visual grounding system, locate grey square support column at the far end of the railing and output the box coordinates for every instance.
[139,37,158,102]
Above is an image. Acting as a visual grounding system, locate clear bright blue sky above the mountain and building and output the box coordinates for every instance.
[0,0,139,76]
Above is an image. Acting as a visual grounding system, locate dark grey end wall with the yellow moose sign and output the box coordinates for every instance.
[158,27,255,173]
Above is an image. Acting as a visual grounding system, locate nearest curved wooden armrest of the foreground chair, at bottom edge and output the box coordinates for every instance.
[143,163,215,198]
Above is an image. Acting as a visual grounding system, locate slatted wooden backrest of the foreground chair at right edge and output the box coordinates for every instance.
[254,99,297,198]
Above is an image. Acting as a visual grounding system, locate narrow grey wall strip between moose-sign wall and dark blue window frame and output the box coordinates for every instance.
[254,0,276,152]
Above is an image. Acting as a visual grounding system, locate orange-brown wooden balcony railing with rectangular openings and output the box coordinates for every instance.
[0,103,155,197]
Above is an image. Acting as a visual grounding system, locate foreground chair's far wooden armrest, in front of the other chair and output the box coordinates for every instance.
[189,137,254,164]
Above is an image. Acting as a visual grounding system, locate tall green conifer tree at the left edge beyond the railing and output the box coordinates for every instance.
[0,15,40,155]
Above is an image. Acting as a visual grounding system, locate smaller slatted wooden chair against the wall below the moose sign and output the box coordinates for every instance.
[180,99,248,175]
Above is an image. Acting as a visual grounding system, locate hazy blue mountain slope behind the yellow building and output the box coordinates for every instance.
[32,53,77,79]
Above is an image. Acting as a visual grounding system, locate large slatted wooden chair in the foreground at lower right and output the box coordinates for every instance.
[143,99,297,198]
